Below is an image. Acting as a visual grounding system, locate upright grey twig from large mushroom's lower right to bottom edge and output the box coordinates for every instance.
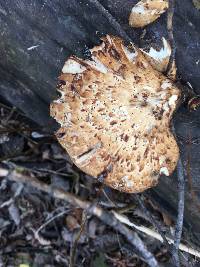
[173,158,185,267]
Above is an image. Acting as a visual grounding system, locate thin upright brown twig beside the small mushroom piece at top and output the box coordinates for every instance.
[166,0,176,73]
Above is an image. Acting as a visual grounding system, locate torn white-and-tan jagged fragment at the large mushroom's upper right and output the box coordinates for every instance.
[140,37,171,73]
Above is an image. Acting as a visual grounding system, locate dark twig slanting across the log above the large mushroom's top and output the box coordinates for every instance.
[88,0,132,43]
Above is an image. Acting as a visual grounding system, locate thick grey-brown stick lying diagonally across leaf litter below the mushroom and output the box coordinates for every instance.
[3,170,158,267]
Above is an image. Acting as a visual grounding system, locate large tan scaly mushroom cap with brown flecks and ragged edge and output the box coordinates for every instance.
[50,35,181,193]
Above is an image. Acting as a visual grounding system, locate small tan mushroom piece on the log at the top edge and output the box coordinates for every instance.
[129,0,169,28]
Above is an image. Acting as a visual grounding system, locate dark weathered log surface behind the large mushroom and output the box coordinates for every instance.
[0,0,200,241]
